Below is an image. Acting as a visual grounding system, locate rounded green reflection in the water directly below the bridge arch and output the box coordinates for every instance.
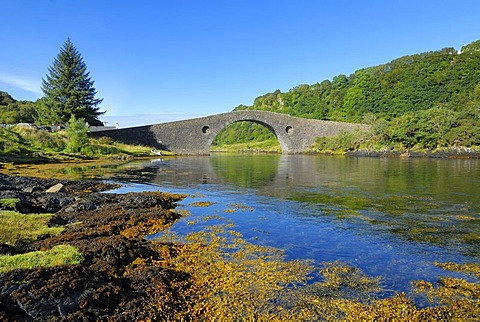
[210,155,280,187]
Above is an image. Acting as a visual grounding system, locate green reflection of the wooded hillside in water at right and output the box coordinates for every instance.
[289,158,480,257]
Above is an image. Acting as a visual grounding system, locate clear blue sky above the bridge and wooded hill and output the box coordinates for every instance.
[0,0,480,127]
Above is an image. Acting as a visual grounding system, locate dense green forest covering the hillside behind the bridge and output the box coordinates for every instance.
[214,40,480,150]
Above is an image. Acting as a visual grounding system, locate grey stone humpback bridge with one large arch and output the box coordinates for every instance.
[92,111,367,154]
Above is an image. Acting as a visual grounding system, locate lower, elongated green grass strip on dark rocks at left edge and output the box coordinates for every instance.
[0,245,83,274]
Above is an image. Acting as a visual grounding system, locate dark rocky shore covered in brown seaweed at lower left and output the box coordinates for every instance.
[0,174,186,321]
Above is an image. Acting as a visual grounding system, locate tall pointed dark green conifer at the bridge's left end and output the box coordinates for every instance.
[36,39,105,125]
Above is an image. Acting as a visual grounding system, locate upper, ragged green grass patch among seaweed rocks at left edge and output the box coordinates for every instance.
[0,211,64,246]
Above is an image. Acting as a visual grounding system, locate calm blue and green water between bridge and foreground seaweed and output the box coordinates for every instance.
[104,154,480,293]
